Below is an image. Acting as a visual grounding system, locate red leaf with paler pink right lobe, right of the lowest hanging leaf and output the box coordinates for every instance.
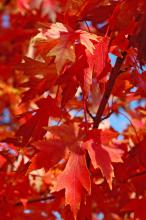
[84,130,123,188]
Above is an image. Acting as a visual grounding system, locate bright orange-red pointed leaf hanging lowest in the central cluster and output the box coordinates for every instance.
[55,152,91,218]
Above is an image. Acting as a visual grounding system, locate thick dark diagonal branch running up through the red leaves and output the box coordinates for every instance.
[93,52,126,128]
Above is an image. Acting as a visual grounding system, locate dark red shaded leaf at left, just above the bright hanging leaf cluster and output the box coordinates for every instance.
[16,96,62,145]
